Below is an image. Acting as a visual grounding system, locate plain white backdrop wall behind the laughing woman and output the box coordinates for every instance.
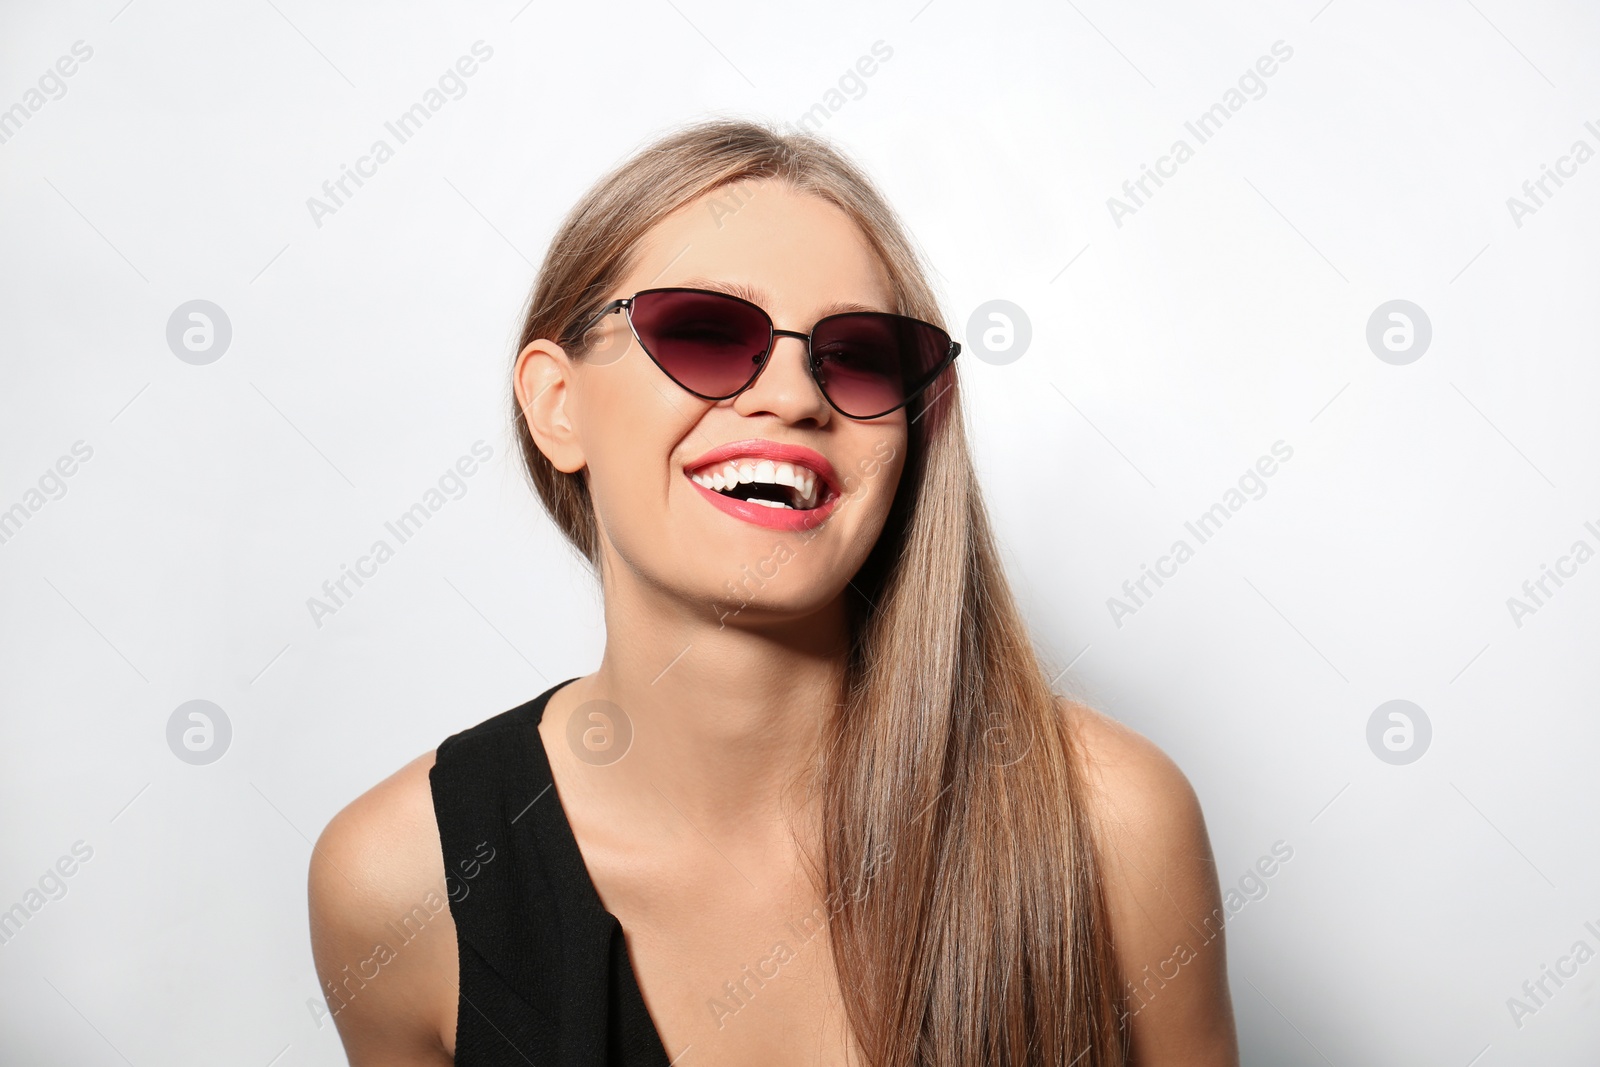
[0,0,1600,1067]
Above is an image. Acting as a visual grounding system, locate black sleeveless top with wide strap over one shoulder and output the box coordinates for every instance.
[429,678,669,1067]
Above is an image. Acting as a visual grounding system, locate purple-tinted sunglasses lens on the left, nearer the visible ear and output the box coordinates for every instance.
[630,290,771,398]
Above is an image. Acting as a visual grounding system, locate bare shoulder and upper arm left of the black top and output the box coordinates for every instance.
[307,752,459,1067]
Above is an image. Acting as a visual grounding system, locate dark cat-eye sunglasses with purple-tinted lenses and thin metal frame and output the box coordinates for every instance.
[573,288,962,419]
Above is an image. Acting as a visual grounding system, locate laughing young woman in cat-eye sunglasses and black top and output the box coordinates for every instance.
[310,122,1237,1067]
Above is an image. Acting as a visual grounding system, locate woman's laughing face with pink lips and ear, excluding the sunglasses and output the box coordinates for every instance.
[517,181,907,625]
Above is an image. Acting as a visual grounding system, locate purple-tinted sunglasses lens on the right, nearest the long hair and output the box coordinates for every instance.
[811,312,950,419]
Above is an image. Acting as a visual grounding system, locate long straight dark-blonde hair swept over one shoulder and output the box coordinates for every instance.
[512,120,1126,1067]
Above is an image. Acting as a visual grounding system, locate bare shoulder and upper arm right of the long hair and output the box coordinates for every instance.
[1062,699,1238,1067]
